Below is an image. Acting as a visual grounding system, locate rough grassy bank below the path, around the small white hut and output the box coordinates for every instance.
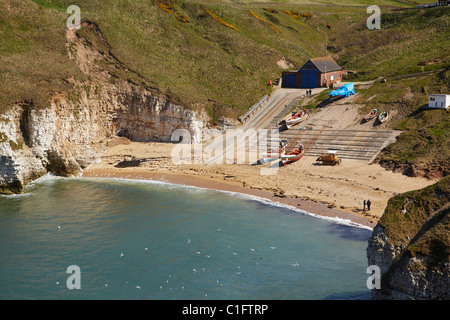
[360,71,450,169]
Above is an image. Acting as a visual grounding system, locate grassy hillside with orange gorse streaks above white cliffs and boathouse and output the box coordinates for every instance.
[0,0,442,119]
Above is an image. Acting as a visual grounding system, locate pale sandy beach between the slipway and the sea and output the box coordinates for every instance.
[83,138,435,228]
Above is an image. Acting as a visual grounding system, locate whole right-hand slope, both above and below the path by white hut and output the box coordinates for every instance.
[330,7,450,178]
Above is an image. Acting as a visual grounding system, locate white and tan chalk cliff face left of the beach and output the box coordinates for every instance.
[0,26,209,193]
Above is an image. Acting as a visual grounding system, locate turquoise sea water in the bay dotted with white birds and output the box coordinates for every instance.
[0,176,371,300]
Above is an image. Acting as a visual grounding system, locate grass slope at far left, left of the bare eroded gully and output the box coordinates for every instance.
[0,1,84,113]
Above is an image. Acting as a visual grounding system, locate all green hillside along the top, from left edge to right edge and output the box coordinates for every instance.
[0,0,449,125]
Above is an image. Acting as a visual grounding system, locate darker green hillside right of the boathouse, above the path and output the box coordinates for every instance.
[335,7,450,80]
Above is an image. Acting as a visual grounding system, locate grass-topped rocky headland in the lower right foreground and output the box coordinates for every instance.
[367,178,450,300]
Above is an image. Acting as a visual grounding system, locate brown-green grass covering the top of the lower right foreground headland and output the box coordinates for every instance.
[379,177,450,288]
